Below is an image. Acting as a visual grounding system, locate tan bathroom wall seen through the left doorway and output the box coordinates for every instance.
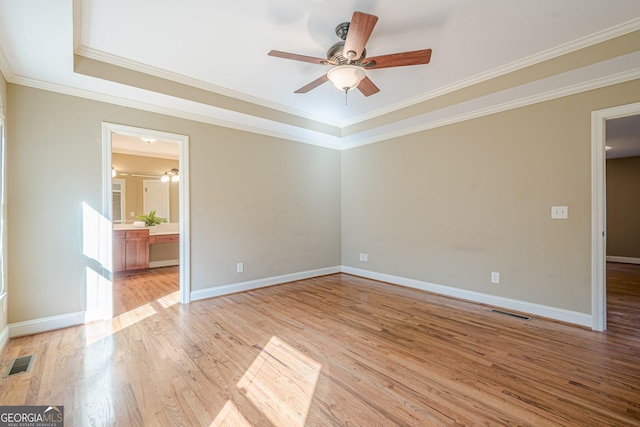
[111,153,180,223]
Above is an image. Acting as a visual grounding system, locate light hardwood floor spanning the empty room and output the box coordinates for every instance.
[0,264,640,427]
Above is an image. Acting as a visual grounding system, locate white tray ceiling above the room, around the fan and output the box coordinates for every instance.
[0,0,640,148]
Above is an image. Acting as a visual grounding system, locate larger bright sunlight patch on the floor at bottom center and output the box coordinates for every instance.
[237,336,322,427]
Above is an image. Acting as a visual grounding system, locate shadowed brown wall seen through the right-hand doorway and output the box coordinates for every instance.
[607,157,640,258]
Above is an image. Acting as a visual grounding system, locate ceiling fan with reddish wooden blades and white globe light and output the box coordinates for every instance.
[268,12,431,96]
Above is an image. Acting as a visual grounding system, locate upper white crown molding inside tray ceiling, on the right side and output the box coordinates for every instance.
[339,18,640,128]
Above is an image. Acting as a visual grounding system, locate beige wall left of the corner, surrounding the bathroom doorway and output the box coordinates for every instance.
[7,84,340,323]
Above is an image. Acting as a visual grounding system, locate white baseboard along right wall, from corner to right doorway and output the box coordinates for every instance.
[342,266,592,328]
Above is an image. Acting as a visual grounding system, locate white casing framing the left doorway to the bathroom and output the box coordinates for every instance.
[102,122,191,304]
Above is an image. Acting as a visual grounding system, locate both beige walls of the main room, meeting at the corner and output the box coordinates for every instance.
[7,75,640,323]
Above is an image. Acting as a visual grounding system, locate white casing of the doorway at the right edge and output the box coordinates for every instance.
[591,102,640,331]
